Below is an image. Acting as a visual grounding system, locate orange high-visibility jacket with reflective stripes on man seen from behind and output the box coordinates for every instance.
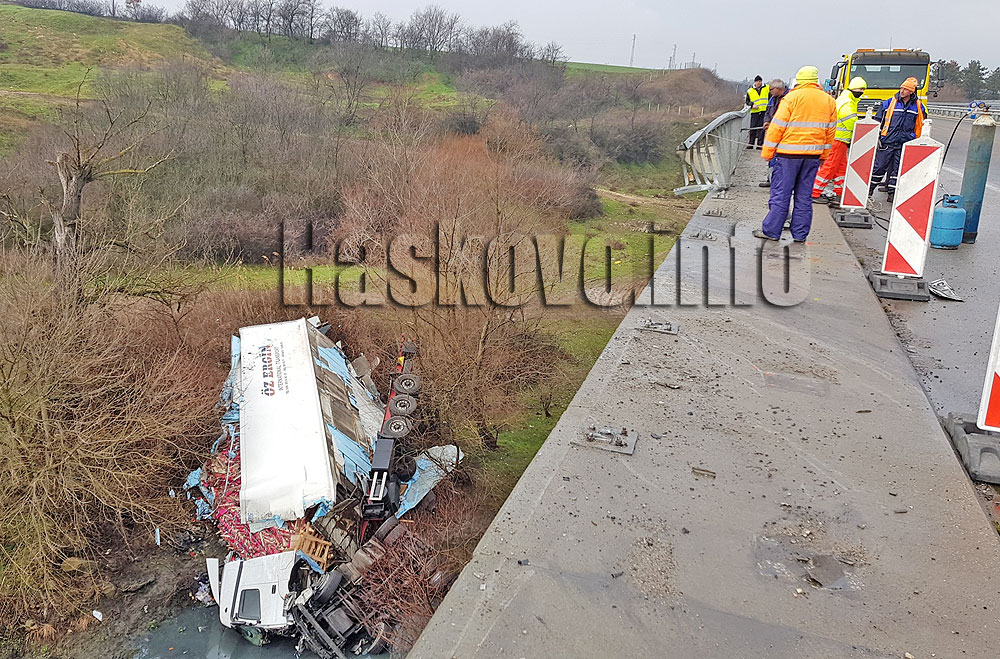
[761,82,837,160]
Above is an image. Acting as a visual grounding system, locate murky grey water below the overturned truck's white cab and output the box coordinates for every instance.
[126,606,388,659]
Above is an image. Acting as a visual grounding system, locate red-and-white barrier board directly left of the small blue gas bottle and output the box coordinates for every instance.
[882,137,944,277]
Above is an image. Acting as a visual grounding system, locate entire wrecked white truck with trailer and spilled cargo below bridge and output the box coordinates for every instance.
[186,317,463,659]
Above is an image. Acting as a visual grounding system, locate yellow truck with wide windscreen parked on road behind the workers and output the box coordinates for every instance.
[830,48,937,115]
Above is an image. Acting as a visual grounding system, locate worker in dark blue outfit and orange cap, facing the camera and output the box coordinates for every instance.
[869,76,927,203]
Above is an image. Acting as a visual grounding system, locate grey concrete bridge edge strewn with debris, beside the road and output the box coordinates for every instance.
[409,152,1000,659]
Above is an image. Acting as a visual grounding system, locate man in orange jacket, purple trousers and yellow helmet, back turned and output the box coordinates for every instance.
[753,66,837,243]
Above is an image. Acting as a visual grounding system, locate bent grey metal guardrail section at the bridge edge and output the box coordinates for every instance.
[674,106,750,195]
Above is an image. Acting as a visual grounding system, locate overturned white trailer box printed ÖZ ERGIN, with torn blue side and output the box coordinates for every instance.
[239,319,384,530]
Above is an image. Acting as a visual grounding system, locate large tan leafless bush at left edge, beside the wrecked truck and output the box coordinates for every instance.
[0,253,218,624]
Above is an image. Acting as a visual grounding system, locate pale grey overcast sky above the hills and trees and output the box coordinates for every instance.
[156,0,1000,80]
